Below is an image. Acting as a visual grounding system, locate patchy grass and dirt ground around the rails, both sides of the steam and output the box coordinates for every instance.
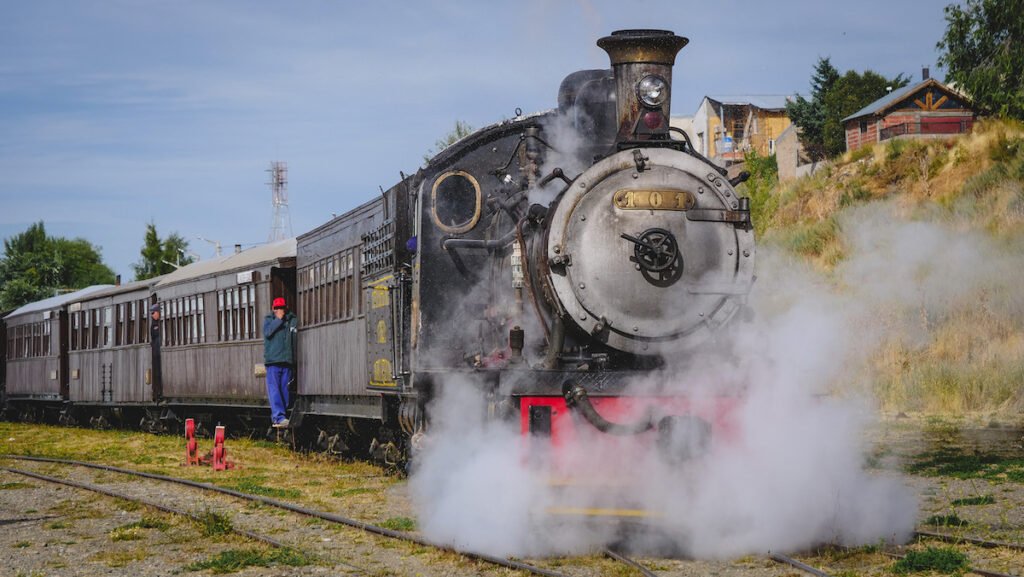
[0,418,1024,577]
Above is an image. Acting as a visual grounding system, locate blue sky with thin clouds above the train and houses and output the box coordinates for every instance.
[0,0,948,281]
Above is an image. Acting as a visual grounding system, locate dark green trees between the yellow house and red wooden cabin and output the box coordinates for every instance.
[785,57,909,160]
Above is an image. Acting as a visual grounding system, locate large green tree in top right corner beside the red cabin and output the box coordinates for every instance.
[936,0,1024,119]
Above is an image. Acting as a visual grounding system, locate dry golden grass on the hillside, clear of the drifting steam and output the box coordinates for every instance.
[761,122,1024,415]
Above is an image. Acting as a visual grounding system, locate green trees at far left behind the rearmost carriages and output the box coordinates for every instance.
[0,221,115,311]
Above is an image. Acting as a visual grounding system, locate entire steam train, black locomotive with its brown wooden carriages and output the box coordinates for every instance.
[4,30,755,479]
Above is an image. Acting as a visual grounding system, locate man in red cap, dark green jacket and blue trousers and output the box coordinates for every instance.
[263,296,299,427]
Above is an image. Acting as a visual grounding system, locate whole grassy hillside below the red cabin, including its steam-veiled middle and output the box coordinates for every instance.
[744,122,1024,418]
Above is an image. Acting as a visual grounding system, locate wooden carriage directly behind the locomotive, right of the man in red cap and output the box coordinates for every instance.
[296,181,410,419]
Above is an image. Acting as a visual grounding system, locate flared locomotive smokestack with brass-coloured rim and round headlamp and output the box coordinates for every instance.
[597,30,689,142]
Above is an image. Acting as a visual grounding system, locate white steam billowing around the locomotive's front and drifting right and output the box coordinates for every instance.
[411,197,1024,558]
